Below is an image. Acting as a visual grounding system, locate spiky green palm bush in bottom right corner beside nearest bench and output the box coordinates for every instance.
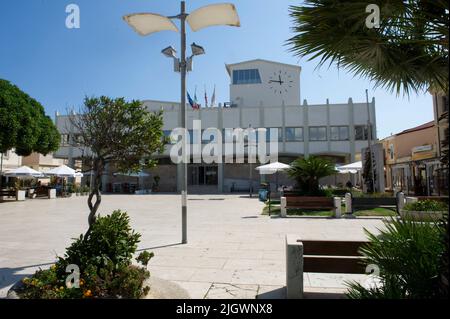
[347,218,445,299]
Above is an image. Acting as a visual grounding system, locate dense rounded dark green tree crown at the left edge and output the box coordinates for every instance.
[0,79,60,156]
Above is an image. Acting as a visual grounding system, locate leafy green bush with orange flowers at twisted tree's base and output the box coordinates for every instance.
[19,210,153,299]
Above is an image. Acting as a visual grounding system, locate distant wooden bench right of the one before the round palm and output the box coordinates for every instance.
[345,193,399,214]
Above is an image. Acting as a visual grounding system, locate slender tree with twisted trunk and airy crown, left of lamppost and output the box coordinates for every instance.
[70,96,164,237]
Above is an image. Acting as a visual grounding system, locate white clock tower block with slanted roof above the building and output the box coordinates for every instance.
[226,59,301,107]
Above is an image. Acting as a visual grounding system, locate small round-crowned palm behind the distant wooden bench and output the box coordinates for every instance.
[287,156,336,195]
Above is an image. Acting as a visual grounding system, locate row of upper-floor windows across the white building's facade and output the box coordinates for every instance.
[164,125,373,144]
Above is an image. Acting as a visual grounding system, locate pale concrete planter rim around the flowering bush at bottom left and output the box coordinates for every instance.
[6,276,191,299]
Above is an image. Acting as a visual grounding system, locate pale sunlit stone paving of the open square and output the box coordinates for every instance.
[0,195,383,298]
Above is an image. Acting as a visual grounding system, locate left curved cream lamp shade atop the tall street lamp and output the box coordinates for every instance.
[123,13,178,36]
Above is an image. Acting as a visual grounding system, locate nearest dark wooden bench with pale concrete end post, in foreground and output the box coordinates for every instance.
[286,235,369,299]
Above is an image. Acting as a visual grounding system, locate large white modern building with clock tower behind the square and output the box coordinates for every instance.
[55,59,376,193]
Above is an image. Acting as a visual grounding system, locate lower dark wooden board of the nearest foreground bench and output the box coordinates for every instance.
[303,256,366,274]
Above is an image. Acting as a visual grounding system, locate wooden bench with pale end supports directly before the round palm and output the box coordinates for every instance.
[280,194,341,217]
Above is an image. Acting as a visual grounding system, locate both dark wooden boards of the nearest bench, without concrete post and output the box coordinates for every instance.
[302,240,368,274]
